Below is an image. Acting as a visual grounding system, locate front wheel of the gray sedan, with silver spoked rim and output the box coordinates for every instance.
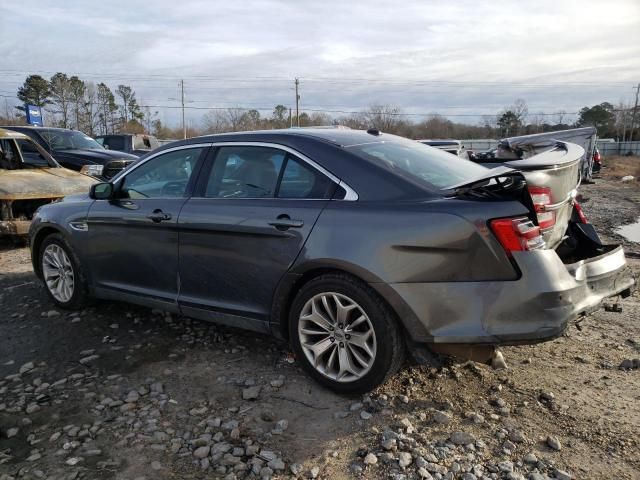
[38,233,88,310]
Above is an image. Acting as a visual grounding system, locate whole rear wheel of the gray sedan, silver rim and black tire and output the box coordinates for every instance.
[289,274,405,394]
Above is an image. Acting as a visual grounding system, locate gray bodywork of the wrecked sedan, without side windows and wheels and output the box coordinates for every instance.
[30,129,634,345]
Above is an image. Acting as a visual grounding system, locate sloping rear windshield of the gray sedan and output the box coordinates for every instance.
[346,137,487,190]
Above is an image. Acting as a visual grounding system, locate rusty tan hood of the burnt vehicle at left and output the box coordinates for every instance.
[0,168,97,200]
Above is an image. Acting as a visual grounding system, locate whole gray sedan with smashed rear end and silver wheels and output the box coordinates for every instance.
[30,129,633,392]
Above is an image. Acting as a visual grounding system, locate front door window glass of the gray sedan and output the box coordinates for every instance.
[120,147,206,199]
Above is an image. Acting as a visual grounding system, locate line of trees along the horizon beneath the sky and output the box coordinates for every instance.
[0,73,640,140]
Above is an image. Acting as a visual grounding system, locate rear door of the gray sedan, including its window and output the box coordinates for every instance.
[178,144,337,330]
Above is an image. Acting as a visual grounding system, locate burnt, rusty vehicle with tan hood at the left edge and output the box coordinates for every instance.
[0,129,96,239]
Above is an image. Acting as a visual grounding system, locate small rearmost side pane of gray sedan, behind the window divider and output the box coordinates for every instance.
[278,156,335,199]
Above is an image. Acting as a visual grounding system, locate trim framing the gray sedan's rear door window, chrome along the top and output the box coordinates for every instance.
[191,142,359,202]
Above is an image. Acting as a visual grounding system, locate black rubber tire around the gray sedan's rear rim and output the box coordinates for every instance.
[289,273,405,394]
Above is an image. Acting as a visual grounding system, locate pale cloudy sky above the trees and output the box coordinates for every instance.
[0,0,640,126]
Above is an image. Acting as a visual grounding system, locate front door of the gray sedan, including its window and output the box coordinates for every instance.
[87,146,208,306]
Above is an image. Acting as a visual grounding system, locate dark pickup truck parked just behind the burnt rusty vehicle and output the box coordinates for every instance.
[0,126,138,180]
